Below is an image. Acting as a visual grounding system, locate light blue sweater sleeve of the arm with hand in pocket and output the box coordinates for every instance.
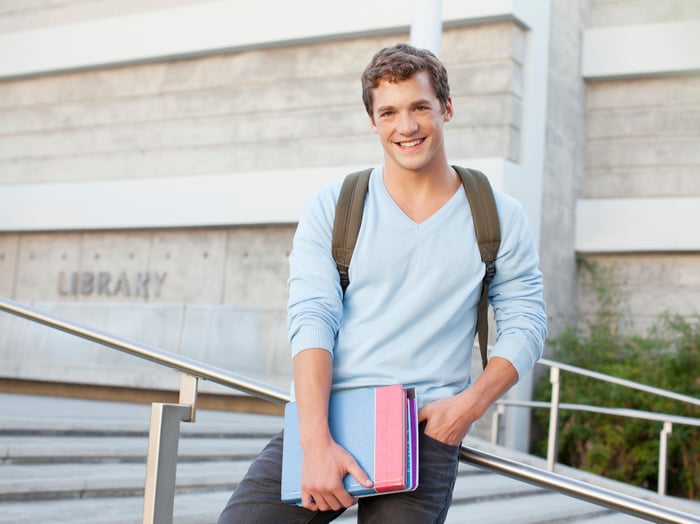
[489,194,547,377]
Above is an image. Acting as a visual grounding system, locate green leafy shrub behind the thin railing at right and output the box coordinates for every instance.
[535,266,700,499]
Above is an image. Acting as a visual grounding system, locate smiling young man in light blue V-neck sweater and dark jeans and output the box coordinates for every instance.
[219,44,546,524]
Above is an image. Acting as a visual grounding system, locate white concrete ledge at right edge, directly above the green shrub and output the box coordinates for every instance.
[576,197,700,253]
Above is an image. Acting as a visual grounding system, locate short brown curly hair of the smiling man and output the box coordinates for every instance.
[362,44,450,118]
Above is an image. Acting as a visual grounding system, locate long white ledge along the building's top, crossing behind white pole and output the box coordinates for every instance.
[0,0,541,78]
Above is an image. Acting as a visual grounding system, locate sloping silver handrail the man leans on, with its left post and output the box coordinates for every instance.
[0,297,700,524]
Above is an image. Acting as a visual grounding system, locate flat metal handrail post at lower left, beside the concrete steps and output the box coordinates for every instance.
[142,373,198,524]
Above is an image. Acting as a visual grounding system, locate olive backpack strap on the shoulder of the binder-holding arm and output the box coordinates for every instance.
[332,168,372,293]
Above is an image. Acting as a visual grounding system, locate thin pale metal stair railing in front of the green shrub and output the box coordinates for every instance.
[491,358,700,495]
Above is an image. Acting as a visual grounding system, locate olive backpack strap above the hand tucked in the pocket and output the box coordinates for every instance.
[452,166,501,368]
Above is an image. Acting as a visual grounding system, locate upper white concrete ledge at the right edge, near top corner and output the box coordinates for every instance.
[581,20,700,80]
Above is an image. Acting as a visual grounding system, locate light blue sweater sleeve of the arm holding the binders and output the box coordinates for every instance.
[287,185,343,357]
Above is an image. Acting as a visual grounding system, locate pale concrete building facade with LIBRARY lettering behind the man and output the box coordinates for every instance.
[0,0,700,446]
